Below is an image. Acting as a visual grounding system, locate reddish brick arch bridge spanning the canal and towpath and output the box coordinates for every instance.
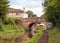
[15,17,53,29]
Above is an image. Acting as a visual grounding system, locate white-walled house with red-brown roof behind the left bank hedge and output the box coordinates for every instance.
[7,8,28,18]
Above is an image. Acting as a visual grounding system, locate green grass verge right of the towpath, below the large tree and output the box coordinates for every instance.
[48,27,60,43]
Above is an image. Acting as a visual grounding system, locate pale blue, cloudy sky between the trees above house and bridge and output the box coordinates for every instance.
[9,0,44,17]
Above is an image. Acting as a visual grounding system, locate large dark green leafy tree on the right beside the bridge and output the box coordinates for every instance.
[43,0,60,26]
